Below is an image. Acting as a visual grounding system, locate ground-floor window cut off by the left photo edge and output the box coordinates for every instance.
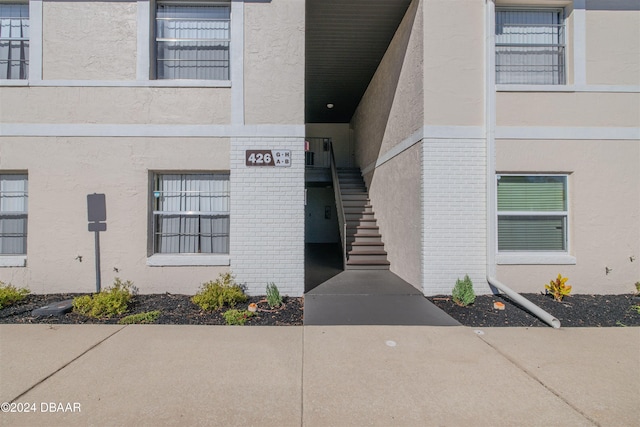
[0,174,28,255]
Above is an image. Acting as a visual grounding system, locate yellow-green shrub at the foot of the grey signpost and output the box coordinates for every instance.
[73,277,136,318]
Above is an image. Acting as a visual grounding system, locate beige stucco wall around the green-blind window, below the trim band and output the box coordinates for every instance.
[497,140,640,294]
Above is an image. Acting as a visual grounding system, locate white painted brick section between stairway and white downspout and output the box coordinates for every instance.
[422,139,490,295]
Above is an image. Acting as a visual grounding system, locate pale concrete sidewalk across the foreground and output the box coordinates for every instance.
[0,325,640,427]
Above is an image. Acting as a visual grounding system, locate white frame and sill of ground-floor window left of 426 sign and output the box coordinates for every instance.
[147,171,231,267]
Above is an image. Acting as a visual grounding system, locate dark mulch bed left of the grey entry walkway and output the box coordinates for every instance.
[0,293,303,326]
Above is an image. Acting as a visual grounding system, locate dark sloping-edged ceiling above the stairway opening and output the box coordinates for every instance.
[305,0,411,123]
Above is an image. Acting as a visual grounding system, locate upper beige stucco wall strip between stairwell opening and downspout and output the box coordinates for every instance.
[424,0,485,126]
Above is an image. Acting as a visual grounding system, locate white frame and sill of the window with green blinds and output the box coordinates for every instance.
[494,173,576,265]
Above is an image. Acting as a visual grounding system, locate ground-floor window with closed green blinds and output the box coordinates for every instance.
[497,175,568,252]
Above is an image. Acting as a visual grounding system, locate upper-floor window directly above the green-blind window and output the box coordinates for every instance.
[496,8,566,85]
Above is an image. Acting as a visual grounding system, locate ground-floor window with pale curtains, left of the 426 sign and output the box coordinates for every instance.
[153,173,229,254]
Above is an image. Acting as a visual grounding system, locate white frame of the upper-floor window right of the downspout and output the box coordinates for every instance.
[494,6,569,86]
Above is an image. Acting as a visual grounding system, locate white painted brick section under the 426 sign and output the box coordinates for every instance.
[230,137,304,296]
